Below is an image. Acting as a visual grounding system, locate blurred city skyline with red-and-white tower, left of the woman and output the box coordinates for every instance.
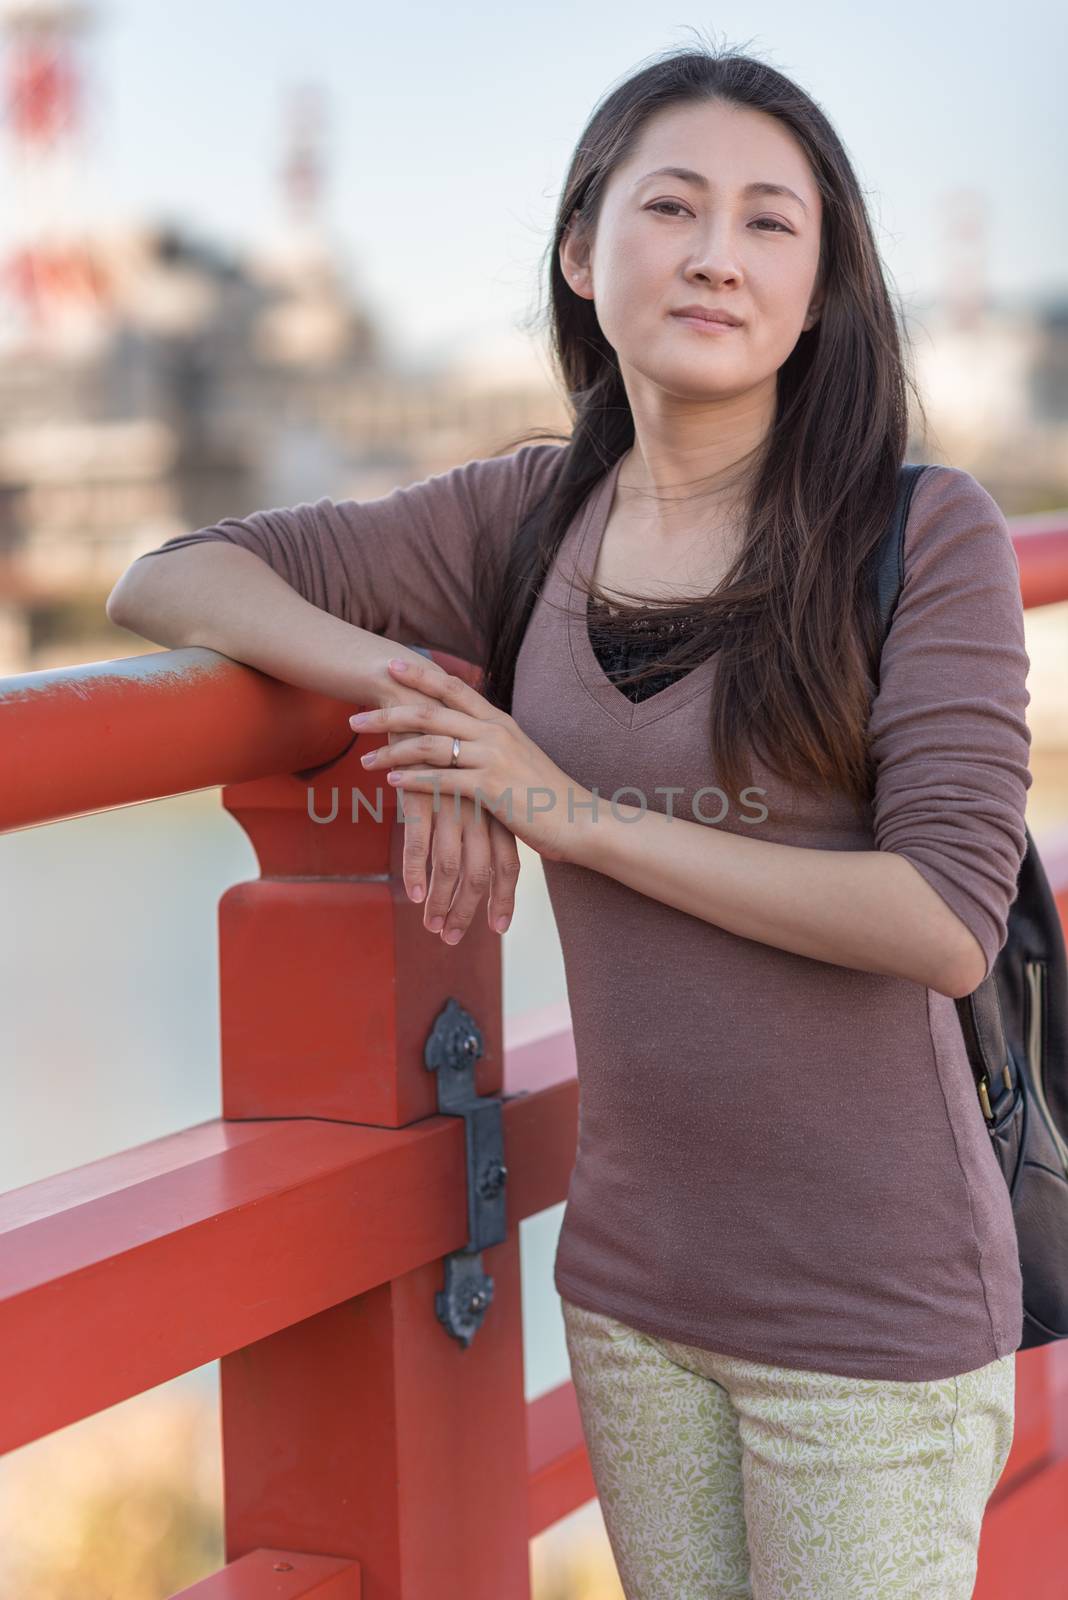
[0,0,563,674]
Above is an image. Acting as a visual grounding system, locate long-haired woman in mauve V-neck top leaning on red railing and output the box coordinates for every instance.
[109,37,1030,1600]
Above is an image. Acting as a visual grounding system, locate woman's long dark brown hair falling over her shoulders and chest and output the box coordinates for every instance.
[475,42,923,803]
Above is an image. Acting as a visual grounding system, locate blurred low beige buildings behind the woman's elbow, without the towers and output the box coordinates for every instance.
[0,203,558,674]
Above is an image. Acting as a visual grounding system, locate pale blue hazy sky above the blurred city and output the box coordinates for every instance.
[0,0,1068,360]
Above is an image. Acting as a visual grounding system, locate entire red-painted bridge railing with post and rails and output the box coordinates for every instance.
[0,514,1068,1600]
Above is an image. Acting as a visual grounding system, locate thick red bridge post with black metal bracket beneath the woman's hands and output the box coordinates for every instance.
[219,739,529,1600]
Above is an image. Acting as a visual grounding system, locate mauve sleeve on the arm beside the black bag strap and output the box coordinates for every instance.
[870,466,1031,974]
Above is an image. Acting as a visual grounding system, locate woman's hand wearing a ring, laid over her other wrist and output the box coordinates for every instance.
[349,659,595,861]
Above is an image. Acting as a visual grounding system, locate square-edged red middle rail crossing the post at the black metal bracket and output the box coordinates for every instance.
[0,1035,579,1453]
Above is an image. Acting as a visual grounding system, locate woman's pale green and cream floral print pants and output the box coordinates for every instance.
[561,1299,1015,1600]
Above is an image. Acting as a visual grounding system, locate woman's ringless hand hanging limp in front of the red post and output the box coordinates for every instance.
[354,656,520,944]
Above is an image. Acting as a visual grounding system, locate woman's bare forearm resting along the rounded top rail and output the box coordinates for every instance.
[107,542,422,701]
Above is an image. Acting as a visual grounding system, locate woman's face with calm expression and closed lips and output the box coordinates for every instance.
[560,102,822,400]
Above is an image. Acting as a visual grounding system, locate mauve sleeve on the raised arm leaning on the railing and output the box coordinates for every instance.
[134,443,566,662]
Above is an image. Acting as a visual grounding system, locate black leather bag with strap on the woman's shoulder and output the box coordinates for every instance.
[875,466,1068,1350]
